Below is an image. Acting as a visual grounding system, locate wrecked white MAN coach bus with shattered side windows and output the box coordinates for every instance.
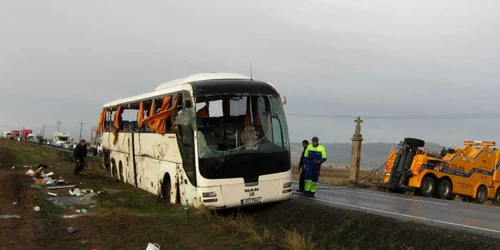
[97,73,292,209]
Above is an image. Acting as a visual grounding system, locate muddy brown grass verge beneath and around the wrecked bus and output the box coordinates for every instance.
[0,142,500,250]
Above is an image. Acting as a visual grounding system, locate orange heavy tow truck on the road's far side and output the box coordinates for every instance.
[381,138,500,205]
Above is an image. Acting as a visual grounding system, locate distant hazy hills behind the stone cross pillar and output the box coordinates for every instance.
[291,142,443,169]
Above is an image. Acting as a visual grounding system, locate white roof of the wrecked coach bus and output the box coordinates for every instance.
[103,73,251,108]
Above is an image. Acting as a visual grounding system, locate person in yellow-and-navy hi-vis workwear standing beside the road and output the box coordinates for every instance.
[304,136,327,197]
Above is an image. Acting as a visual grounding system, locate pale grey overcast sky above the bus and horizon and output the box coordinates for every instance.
[0,0,500,146]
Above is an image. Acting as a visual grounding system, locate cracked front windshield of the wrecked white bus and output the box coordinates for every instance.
[196,94,291,182]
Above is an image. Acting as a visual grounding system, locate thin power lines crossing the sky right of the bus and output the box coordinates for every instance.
[286,113,500,120]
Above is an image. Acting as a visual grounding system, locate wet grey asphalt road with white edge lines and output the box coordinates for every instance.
[293,182,500,239]
